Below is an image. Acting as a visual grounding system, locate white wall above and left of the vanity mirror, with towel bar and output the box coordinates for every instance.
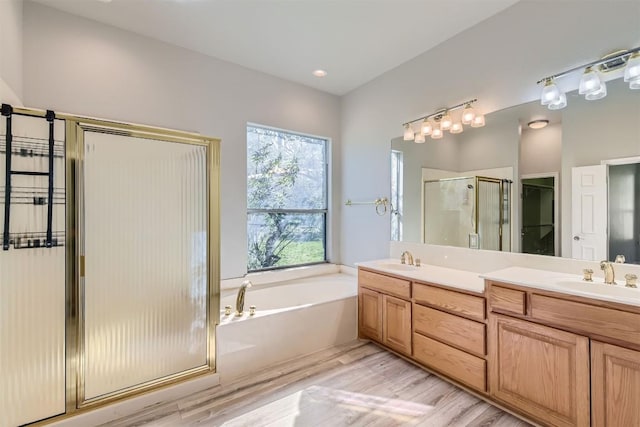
[341,0,640,264]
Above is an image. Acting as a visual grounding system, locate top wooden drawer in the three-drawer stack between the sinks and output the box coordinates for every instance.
[413,283,485,320]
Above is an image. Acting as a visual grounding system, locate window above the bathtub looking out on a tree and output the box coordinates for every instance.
[247,125,327,272]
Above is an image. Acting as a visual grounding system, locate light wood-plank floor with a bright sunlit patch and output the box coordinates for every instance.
[105,342,529,427]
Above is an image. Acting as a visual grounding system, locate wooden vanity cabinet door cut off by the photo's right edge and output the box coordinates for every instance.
[591,341,640,427]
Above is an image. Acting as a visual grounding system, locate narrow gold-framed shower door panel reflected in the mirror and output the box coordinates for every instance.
[478,178,502,251]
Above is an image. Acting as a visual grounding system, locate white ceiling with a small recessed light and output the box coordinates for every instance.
[35,0,518,95]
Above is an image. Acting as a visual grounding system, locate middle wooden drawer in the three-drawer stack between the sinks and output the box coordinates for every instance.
[413,303,486,356]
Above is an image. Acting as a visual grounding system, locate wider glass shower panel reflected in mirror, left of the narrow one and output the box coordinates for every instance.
[424,178,476,247]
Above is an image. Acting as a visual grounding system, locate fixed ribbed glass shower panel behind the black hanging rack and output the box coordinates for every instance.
[0,115,65,426]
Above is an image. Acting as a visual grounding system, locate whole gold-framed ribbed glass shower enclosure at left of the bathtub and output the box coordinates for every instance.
[0,104,219,427]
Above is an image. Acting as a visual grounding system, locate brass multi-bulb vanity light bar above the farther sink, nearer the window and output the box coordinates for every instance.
[403,99,484,143]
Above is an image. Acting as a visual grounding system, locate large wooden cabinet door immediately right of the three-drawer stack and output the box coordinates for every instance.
[489,315,590,426]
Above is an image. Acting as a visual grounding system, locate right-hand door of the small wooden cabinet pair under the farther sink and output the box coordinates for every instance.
[382,295,411,356]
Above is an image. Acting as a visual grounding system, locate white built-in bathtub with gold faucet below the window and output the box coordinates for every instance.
[216,274,358,383]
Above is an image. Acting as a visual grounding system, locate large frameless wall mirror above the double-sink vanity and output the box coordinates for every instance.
[391,79,640,262]
